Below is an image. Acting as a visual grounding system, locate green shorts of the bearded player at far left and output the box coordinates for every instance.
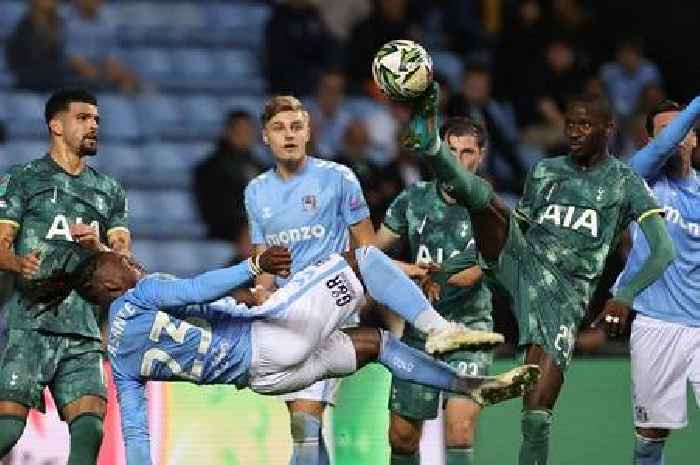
[0,329,107,412]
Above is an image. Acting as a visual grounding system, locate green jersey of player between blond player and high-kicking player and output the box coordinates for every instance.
[384,182,492,332]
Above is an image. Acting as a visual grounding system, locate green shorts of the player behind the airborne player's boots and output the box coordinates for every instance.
[389,340,493,420]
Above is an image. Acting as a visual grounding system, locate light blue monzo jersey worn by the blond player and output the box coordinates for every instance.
[245,157,369,286]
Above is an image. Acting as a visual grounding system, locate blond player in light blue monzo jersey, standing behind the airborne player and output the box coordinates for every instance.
[245,96,374,465]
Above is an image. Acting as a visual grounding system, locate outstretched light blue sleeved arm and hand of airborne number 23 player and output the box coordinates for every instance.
[135,247,291,308]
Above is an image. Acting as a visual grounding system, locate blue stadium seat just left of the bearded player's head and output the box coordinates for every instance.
[6,92,47,139]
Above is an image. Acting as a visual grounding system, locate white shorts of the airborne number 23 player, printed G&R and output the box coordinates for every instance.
[249,255,364,403]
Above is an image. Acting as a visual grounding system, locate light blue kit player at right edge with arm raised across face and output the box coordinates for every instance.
[599,97,700,465]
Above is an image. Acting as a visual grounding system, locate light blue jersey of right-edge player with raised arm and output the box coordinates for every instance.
[614,98,700,327]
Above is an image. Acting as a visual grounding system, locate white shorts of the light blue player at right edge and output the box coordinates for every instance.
[630,314,700,429]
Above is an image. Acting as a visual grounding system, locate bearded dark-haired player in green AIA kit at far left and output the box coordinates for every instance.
[0,90,130,465]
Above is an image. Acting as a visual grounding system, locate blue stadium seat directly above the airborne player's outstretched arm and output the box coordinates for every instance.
[134,240,234,278]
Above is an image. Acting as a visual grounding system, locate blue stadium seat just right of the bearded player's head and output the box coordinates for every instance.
[98,95,144,142]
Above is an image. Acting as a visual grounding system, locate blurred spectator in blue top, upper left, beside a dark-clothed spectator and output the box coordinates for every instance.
[66,0,141,92]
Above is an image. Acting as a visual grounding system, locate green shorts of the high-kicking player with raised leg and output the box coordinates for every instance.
[484,215,586,371]
